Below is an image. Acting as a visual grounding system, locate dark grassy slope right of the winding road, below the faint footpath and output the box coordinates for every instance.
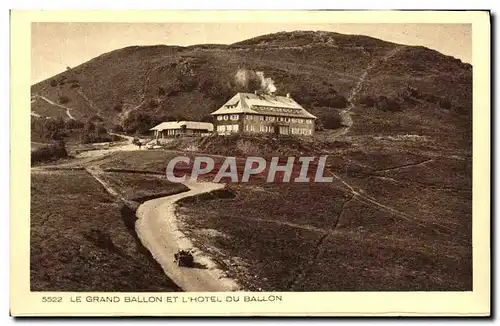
[179,178,472,291]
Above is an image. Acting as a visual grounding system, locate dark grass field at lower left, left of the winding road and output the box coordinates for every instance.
[30,171,180,292]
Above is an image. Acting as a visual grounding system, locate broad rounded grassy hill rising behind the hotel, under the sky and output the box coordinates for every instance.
[32,32,472,146]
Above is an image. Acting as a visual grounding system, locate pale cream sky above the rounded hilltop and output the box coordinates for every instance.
[31,22,472,83]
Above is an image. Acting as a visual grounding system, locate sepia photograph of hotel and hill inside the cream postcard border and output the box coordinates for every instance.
[9,9,489,316]
